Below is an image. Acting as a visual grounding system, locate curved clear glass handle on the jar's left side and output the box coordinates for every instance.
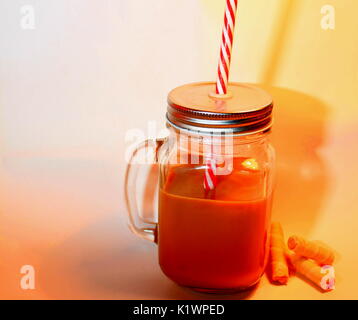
[124,139,165,242]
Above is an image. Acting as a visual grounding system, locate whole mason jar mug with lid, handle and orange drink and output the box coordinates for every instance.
[126,83,275,294]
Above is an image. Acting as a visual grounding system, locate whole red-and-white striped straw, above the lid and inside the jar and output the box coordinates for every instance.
[204,0,238,191]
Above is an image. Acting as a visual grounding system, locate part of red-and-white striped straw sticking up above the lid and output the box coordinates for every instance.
[216,0,238,95]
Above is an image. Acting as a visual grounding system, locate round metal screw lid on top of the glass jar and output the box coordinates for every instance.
[167,82,273,134]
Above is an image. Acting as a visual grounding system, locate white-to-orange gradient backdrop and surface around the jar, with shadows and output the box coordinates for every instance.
[0,0,358,299]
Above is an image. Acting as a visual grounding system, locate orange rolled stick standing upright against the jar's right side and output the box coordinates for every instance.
[270,222,289,284]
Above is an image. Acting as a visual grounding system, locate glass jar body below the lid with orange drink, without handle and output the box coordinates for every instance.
[158,127,275,292]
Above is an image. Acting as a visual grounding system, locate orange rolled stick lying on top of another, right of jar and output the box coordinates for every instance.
[287,236,335,265]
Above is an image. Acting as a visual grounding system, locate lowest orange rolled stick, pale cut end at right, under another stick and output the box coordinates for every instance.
[287,253,335,291]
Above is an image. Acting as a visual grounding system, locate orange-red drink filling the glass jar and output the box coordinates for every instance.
[158,158,271,291]
